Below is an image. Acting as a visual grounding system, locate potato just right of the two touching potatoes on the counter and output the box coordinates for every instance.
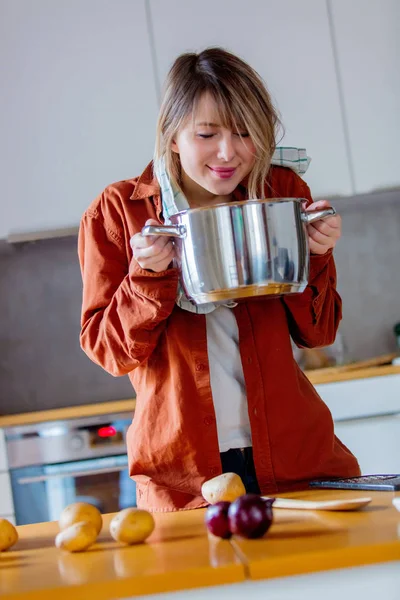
[110,508,155,544]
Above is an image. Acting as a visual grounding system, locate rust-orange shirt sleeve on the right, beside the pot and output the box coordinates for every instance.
[282,178,342,348]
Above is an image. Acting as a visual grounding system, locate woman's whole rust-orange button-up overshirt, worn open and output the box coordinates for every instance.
[79,164,359,511]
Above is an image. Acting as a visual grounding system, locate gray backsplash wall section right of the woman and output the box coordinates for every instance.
[333,190,400,360]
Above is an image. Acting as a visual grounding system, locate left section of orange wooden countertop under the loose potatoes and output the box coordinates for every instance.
[0,502,245,600]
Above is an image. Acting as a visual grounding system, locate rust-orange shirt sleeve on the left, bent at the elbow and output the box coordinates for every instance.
[78,199,178,376]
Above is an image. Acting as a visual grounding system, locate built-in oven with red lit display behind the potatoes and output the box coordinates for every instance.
[5,413,136,525]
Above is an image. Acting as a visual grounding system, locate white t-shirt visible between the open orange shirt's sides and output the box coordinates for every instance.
[206,306,252,452]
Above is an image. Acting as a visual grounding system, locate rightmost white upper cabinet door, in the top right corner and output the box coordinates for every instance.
[331,0,400,192]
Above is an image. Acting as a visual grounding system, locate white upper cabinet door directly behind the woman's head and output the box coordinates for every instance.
[150,0,352,196]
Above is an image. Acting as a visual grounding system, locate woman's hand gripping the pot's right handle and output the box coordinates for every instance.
[306,200,342,254]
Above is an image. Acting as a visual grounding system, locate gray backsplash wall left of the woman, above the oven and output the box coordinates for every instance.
[0,237,134,414]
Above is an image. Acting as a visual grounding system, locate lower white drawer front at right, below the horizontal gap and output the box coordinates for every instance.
[335,413,400,475]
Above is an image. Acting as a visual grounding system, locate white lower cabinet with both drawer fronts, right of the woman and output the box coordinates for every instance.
[315,375,400,475]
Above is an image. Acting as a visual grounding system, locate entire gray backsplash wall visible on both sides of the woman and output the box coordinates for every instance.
[0,192,400,414]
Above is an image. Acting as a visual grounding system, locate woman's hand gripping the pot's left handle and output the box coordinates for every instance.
[130,219,175,273]
